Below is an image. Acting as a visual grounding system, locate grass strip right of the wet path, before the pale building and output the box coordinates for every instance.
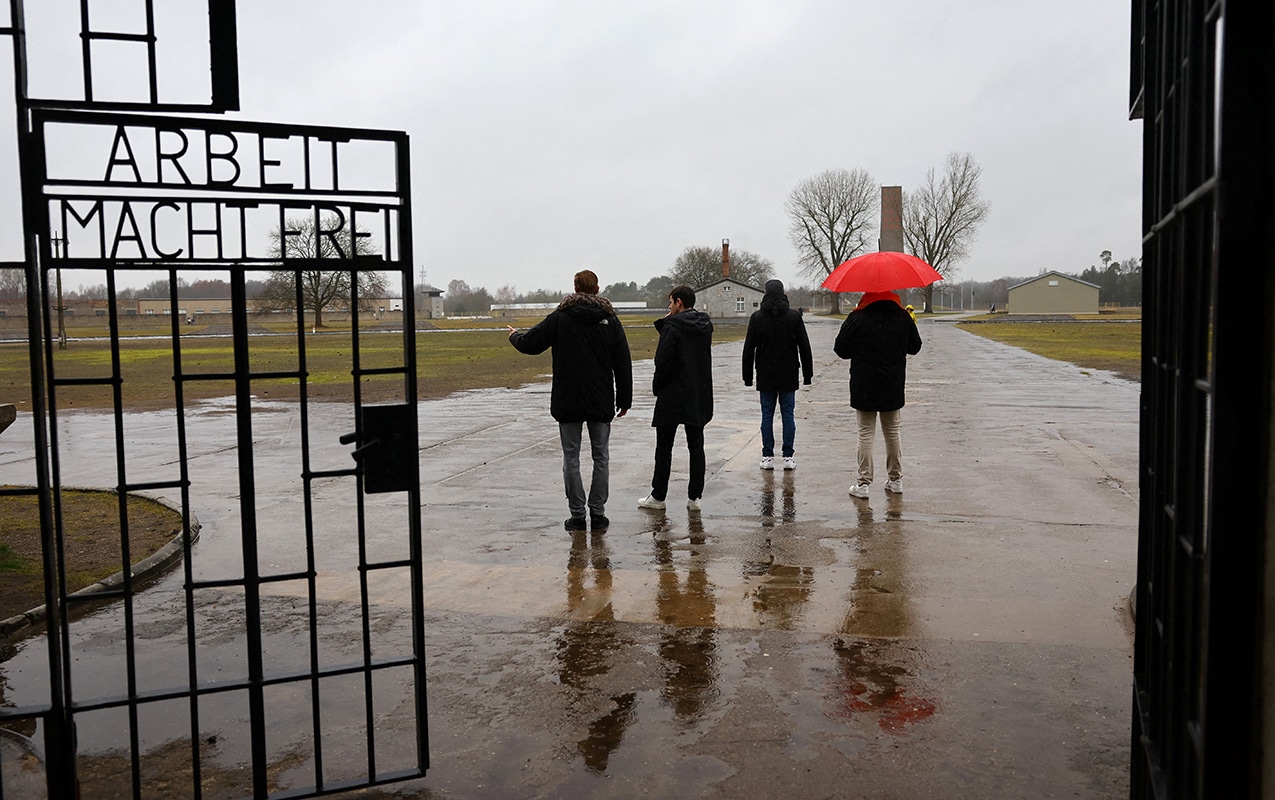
[959,316,1142,380]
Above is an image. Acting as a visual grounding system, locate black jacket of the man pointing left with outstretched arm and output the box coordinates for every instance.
[509,293,634,422]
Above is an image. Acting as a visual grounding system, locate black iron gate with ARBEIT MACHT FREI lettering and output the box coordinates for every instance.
[0,0,428,797]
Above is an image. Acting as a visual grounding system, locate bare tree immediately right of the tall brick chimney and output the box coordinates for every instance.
[903,153,991,315]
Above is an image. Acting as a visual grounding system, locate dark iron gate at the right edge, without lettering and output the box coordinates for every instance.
[1131,0,1275,797]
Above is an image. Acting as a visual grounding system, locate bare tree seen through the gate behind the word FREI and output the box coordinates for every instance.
[255,213,389,328]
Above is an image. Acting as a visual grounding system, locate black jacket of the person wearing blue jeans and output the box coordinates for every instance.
[743,291,815,392]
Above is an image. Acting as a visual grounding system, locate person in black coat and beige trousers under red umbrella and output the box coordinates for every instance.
[833,292,921,499]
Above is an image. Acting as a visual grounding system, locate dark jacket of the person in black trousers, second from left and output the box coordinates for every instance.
[650,309,713,426]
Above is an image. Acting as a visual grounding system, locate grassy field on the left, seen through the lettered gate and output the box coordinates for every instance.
[0,316,745,410]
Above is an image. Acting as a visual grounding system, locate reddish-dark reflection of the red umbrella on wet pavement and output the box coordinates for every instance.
[825,638,938,735]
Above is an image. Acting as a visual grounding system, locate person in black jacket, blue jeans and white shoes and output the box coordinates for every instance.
[743,281,815,470]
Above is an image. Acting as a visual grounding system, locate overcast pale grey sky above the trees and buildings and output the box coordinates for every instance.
[2,0,1141,291]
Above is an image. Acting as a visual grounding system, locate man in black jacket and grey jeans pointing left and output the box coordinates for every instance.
[509,269,634,531]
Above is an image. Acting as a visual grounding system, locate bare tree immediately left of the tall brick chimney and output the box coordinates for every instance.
[784,168,881,314]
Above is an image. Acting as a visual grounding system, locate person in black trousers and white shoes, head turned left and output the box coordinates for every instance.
[638,286,713,512]
